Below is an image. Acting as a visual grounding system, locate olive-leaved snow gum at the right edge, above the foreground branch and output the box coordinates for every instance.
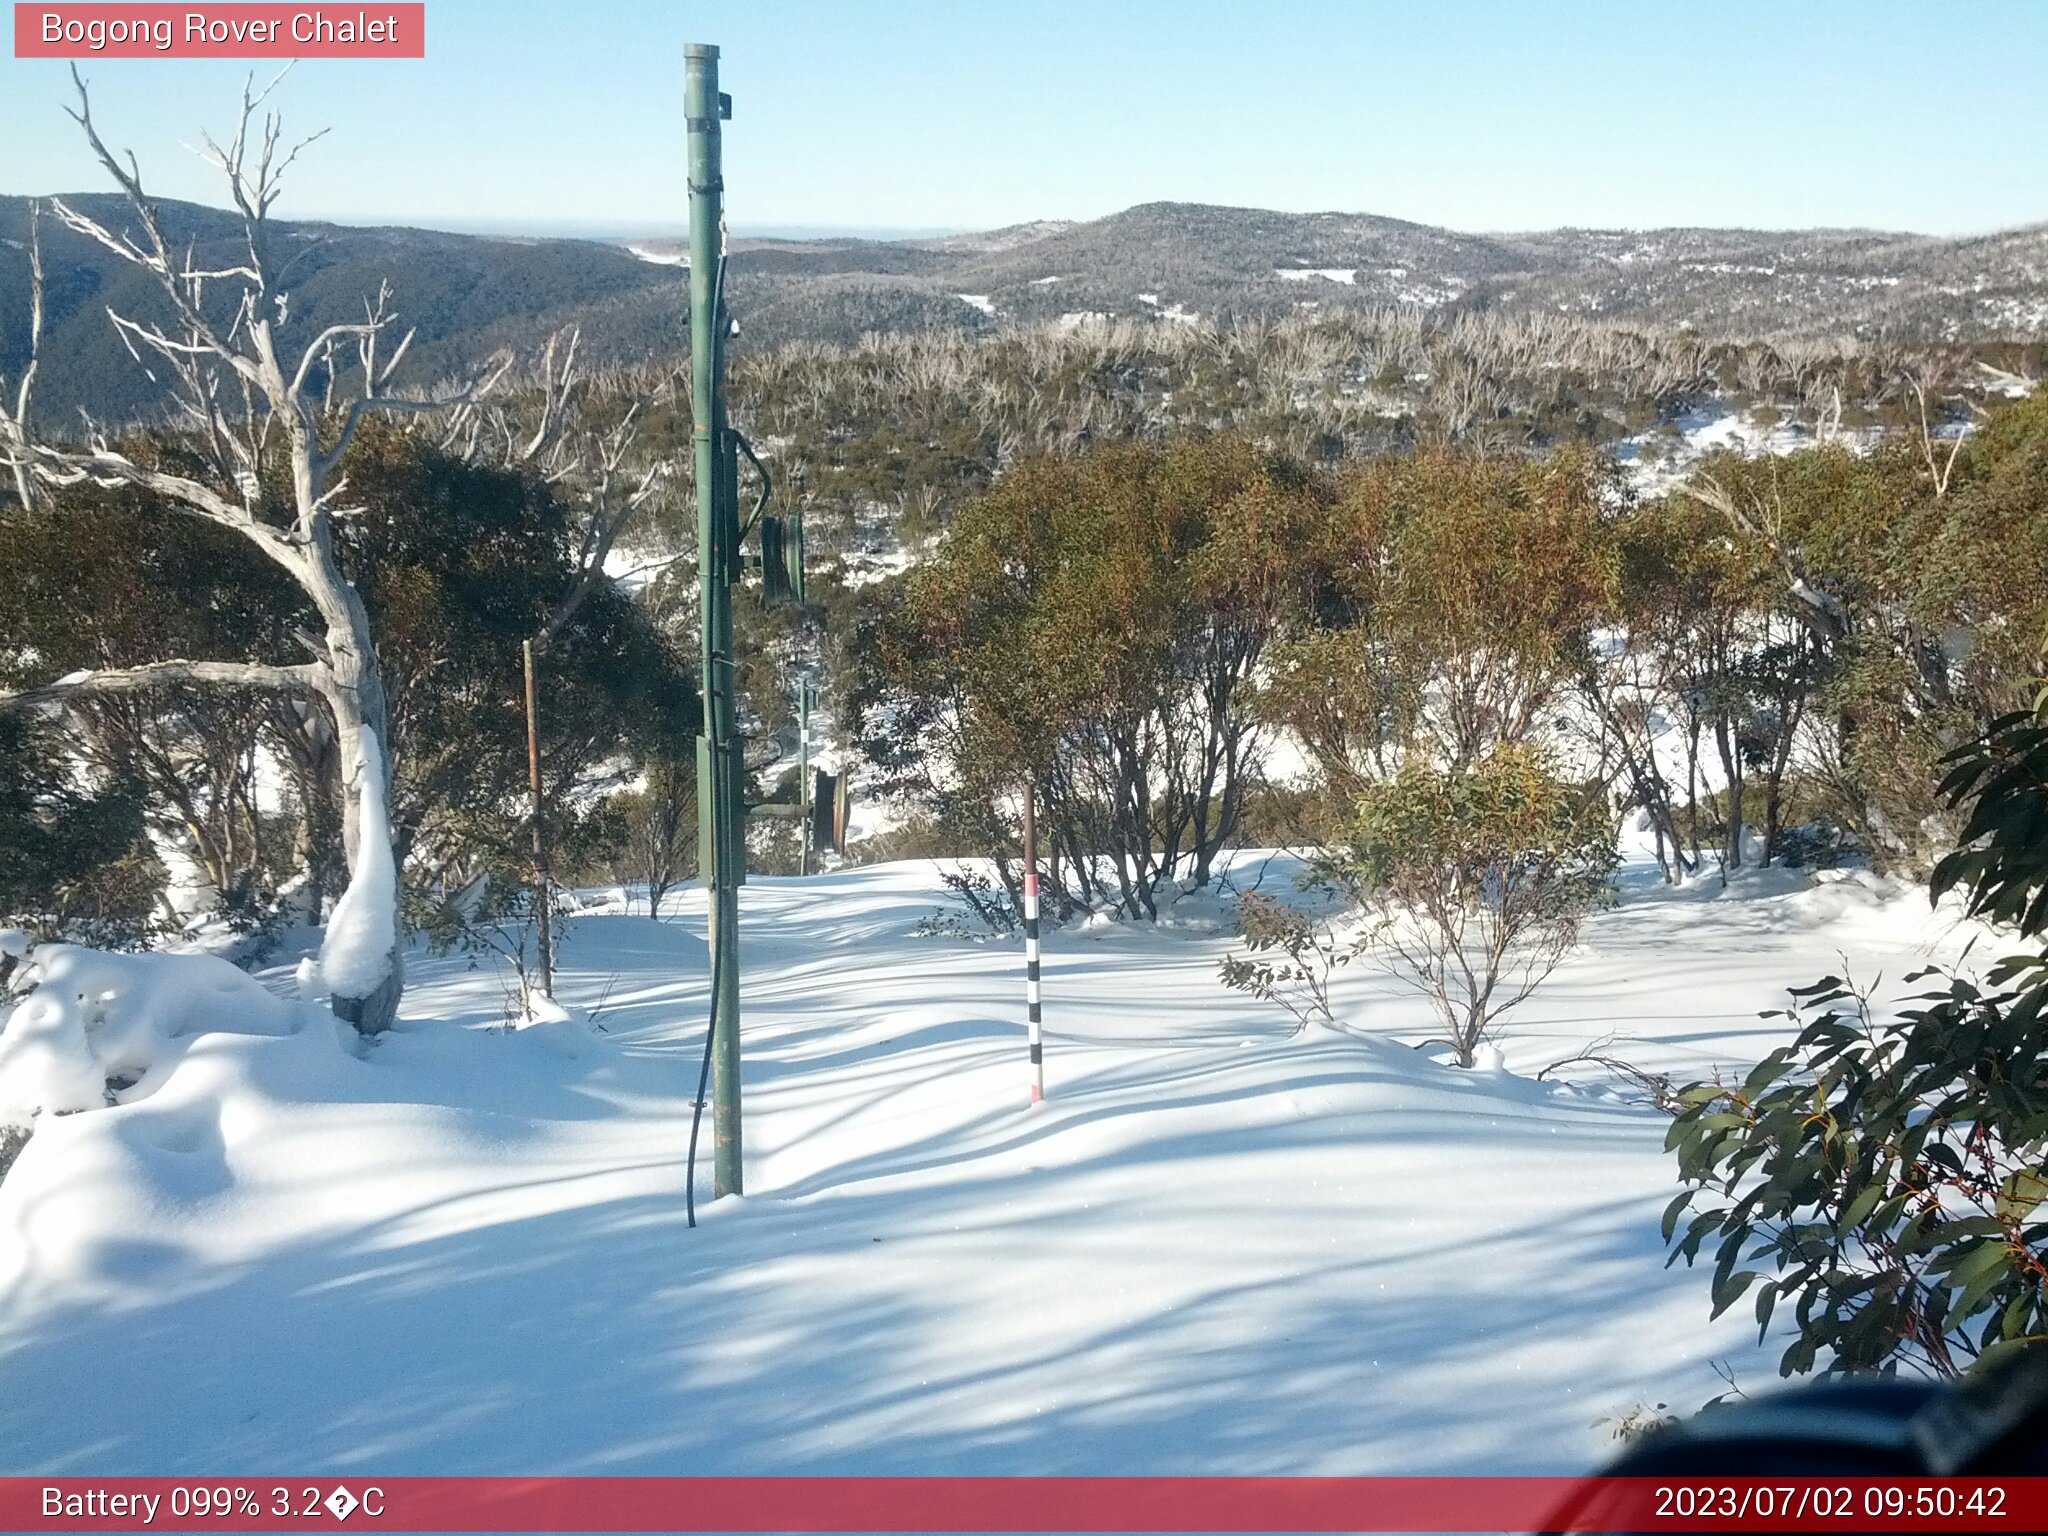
[1642,393,2048,868]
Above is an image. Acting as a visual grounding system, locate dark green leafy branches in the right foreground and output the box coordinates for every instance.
[1663,696,2048,1376]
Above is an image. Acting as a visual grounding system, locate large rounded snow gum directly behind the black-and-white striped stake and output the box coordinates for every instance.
[854,438,1329,918]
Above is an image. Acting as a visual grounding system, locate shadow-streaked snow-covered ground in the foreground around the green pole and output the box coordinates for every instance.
[0,843,1962,1475]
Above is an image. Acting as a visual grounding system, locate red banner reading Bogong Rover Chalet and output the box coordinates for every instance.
[14,0,426,59]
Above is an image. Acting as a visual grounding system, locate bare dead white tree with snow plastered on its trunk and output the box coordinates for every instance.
[0,68,506,1034]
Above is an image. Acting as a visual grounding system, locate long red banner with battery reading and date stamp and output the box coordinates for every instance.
[0,1477,2048,1532]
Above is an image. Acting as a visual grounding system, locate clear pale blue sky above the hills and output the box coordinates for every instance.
[0,0,2048,233]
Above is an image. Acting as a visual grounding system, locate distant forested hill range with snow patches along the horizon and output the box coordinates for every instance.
[0,195,2048,430]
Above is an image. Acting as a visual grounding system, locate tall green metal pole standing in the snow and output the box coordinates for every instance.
[684,43,745,1196]
